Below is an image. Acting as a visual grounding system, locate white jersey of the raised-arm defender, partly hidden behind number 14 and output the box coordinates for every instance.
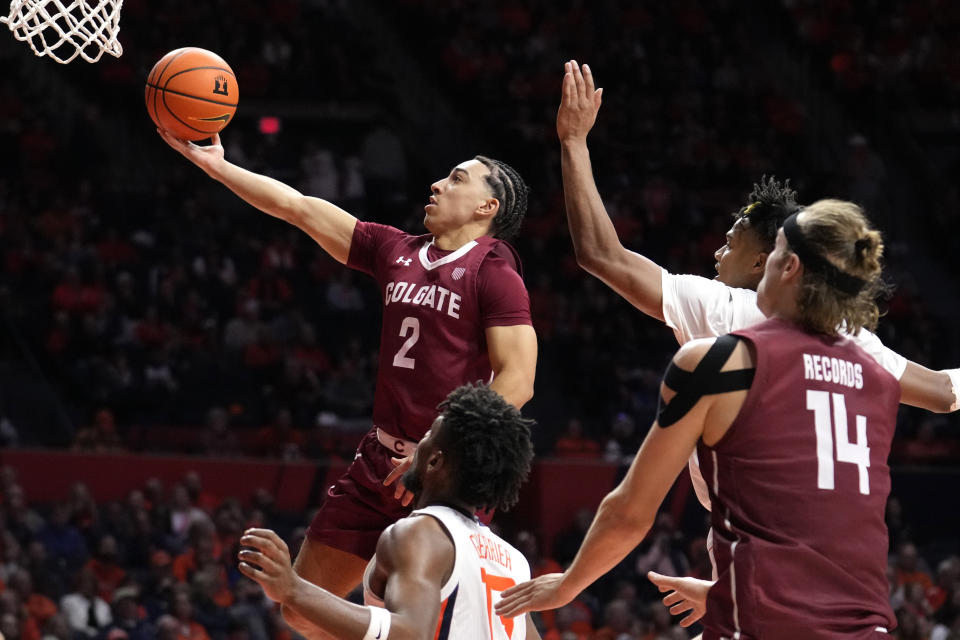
[661,269,907,511]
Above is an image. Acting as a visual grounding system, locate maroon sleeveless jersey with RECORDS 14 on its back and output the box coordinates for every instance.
[698,319,900,640]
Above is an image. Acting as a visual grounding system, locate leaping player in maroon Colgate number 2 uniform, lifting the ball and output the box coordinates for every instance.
[160,131,537,638]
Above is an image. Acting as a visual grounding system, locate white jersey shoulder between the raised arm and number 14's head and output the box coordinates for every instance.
[661,269,765,344]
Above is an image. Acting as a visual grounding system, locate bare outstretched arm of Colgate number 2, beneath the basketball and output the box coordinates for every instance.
[157,129,357,264]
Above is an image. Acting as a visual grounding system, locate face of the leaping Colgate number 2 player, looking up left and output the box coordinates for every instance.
[423,160,496,236]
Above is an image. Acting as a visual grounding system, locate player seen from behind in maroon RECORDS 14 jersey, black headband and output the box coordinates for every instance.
[496,200,898,640]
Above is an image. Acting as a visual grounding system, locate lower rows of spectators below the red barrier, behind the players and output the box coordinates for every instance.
[0,467,960,640]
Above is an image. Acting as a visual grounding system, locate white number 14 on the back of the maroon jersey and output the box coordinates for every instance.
[807,389,870,496]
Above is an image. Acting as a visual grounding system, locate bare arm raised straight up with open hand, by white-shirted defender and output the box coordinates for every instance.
[557,60,663,320]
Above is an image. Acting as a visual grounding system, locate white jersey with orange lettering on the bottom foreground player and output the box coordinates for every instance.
[363,505,530,640]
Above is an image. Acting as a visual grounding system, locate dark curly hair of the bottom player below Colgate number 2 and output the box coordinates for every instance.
[438,382,533,511]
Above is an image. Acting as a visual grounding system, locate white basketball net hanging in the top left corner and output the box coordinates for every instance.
[0,0,123,64]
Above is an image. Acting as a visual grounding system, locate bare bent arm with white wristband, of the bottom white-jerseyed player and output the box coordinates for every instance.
[240,518,454,640]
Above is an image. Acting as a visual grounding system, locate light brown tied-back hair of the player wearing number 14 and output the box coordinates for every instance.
[797,200,890,335]
